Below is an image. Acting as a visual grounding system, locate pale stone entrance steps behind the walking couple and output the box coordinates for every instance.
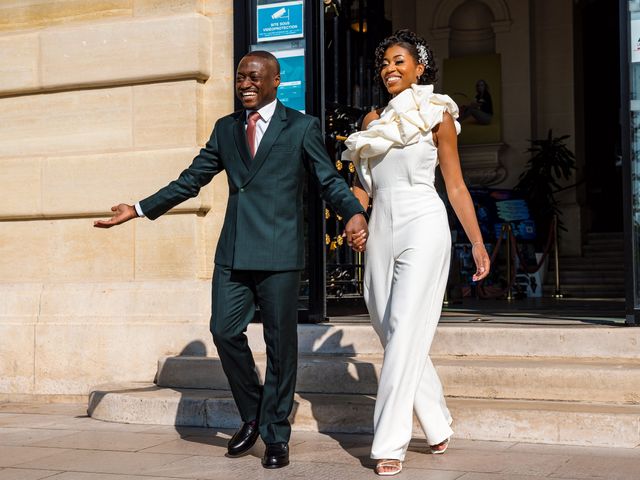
[89,323,640,447]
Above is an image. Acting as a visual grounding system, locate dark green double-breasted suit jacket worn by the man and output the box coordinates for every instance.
[140,101,362,271]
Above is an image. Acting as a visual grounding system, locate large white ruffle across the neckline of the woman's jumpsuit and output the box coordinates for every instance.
[342,84,460,195]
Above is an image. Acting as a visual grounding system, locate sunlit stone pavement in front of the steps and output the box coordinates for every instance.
[0,403,640,480]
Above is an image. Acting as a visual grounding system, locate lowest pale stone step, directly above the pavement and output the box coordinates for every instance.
[88,383,640,448]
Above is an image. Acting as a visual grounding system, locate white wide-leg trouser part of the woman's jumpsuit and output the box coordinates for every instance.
[364,214,453,460]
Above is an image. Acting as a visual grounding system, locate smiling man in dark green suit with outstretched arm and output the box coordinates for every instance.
[94,51,367,468]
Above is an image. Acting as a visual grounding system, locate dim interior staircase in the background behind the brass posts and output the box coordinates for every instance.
[543,232,625,298]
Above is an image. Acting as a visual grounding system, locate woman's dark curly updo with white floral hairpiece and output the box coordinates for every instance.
[375,28,438,87]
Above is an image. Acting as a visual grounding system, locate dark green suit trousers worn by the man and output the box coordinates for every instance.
[211,265,300,444]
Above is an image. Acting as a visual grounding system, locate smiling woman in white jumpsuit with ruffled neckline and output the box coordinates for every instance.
[345,30,489,475]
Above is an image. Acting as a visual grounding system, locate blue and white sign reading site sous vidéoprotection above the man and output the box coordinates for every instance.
[256,0,304,42]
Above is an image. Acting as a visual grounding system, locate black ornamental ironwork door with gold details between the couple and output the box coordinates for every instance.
[323,0,391,313]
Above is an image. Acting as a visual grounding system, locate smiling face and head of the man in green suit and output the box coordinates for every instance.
[236,54,280,110]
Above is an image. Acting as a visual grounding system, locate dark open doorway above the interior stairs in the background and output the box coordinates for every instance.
[574,0,623,232]
